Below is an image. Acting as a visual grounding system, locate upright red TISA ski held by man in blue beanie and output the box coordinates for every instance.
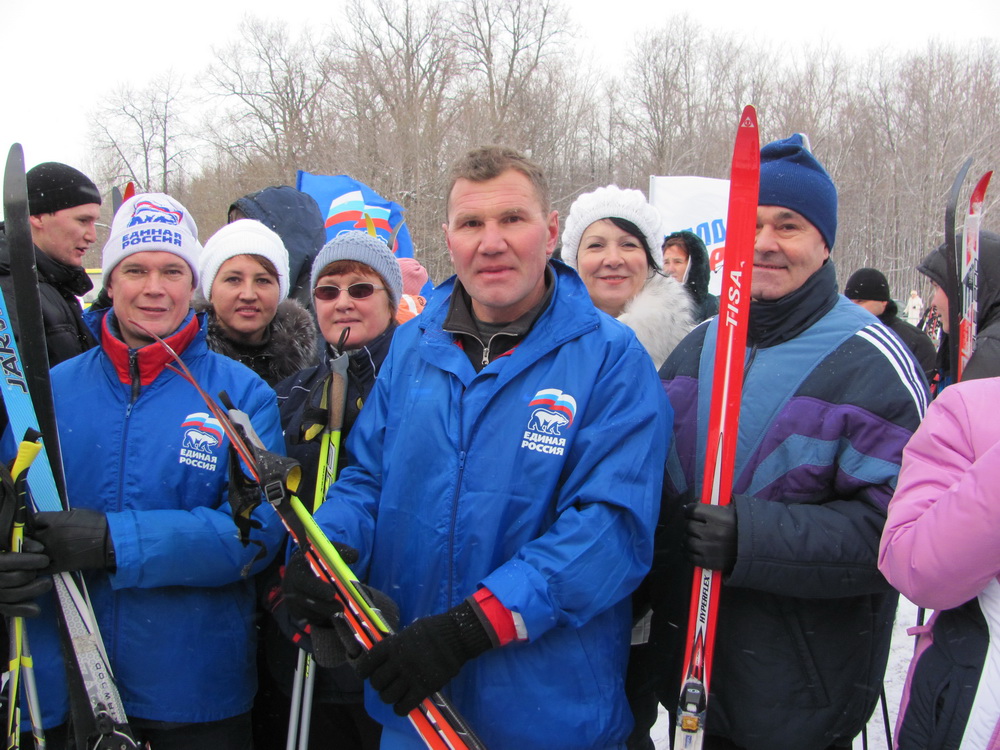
[674,106,760,750]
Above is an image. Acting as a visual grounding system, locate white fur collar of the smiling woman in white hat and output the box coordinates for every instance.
[618,273,694,370]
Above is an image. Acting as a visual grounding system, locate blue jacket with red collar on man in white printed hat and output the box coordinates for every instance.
[28,310,284,727]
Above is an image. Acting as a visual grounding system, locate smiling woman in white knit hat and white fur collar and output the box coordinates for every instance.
[562,185,694,368]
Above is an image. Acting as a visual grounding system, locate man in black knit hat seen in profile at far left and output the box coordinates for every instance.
[0,161,101,366]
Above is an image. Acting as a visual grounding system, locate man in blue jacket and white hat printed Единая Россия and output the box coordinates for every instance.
[9,193,283,750]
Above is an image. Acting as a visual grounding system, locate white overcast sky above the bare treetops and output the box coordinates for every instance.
[0,0,1000,207]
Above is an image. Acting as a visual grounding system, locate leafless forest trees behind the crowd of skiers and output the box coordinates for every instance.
[88,0,1000,299]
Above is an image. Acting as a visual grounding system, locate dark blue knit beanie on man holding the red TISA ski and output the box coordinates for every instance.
[757,133,837,250]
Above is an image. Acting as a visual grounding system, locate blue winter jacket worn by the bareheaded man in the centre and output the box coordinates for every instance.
[317,262,672,750]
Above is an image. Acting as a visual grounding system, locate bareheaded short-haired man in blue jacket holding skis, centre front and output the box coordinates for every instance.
[286,147,671,750]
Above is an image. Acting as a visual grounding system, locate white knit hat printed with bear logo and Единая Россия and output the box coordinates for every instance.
[101,193,201,286]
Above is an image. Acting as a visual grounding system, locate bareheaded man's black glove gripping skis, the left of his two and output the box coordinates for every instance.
[275,542,399,667]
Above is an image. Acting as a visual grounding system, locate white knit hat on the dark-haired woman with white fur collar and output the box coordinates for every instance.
[561,185,663,268]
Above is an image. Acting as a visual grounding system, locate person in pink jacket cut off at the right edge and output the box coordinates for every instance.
[879,378,1000,750]
